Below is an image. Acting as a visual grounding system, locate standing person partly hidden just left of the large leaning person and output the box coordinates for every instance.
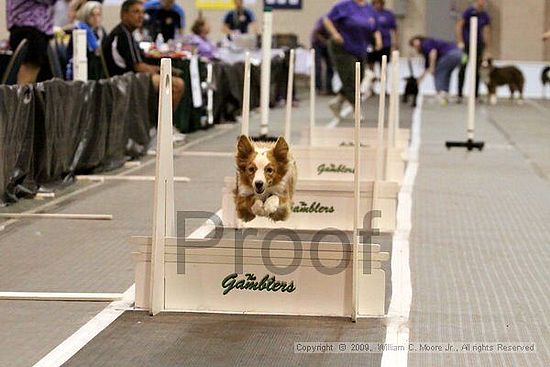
[311,17,334,94]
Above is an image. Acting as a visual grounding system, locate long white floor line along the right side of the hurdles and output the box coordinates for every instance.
[381,96,423,367]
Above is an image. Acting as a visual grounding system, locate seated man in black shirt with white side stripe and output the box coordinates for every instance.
[103,0,184,109]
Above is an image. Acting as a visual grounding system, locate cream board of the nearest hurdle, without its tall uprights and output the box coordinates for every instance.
[131,237,389,317]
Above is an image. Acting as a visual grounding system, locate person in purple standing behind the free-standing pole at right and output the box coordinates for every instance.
[456,0,491,103]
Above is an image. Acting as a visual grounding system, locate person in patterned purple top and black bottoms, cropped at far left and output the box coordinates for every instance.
[6,0,57,84]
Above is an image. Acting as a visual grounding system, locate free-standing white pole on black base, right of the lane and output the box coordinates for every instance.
[445,17,485,151]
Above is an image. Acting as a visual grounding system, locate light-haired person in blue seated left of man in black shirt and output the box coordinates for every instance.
[66,1,106,80]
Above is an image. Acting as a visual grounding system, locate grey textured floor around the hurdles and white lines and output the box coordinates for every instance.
[0,98,550,366]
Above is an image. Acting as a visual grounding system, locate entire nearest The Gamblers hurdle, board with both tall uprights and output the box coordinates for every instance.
[132,60,389,321]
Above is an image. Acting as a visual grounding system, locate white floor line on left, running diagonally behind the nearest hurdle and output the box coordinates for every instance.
[34,209,222,367]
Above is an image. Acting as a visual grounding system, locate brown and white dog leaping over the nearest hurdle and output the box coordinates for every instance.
[234,135,297,222]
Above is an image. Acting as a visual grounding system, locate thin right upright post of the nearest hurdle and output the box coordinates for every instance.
[351,62,361,322]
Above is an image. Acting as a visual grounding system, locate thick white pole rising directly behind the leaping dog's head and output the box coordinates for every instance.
[260,8,273,136]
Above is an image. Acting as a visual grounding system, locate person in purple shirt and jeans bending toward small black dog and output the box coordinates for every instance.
[409,36,462,105]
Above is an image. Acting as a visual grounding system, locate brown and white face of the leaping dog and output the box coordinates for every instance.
[236,135,289,195]
